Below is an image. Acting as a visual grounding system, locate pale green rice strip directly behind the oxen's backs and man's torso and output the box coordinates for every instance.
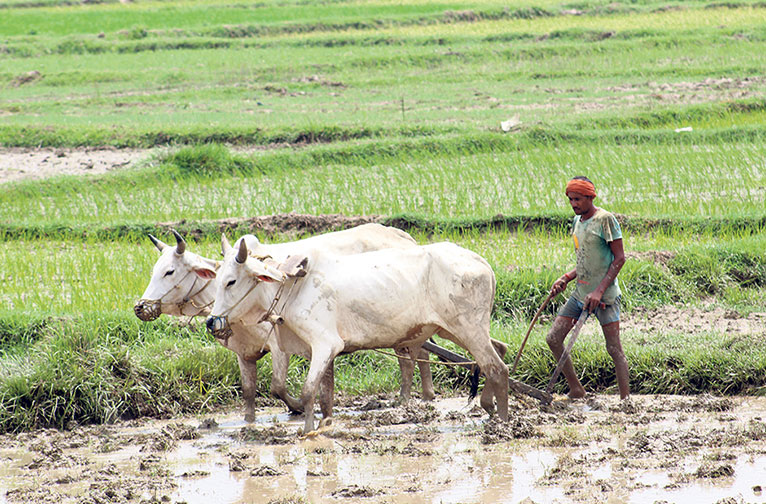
[0,230,766,318]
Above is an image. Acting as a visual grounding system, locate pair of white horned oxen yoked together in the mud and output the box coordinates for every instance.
[134,224,508,433]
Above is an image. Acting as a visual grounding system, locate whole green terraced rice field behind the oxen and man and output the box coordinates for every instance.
[0,0,766,502]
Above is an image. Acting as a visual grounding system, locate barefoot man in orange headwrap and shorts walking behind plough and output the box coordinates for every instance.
[546,176,630,399]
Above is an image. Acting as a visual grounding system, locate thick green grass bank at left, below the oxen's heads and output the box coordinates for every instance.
[0,312,239,432]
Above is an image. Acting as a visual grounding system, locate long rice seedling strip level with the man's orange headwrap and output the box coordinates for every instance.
[0,137,766,225]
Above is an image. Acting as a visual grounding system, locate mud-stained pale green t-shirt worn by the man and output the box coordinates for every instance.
[572,208,622,305]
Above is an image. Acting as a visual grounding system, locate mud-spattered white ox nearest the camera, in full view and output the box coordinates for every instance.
[204,241,508,432]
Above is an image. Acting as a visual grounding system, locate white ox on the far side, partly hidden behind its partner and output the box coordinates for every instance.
[134,224,434,421]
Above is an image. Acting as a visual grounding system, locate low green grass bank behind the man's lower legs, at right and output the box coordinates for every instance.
[504,322,766,395]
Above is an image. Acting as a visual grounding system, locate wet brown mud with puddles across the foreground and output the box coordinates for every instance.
[0,396,766,504]
